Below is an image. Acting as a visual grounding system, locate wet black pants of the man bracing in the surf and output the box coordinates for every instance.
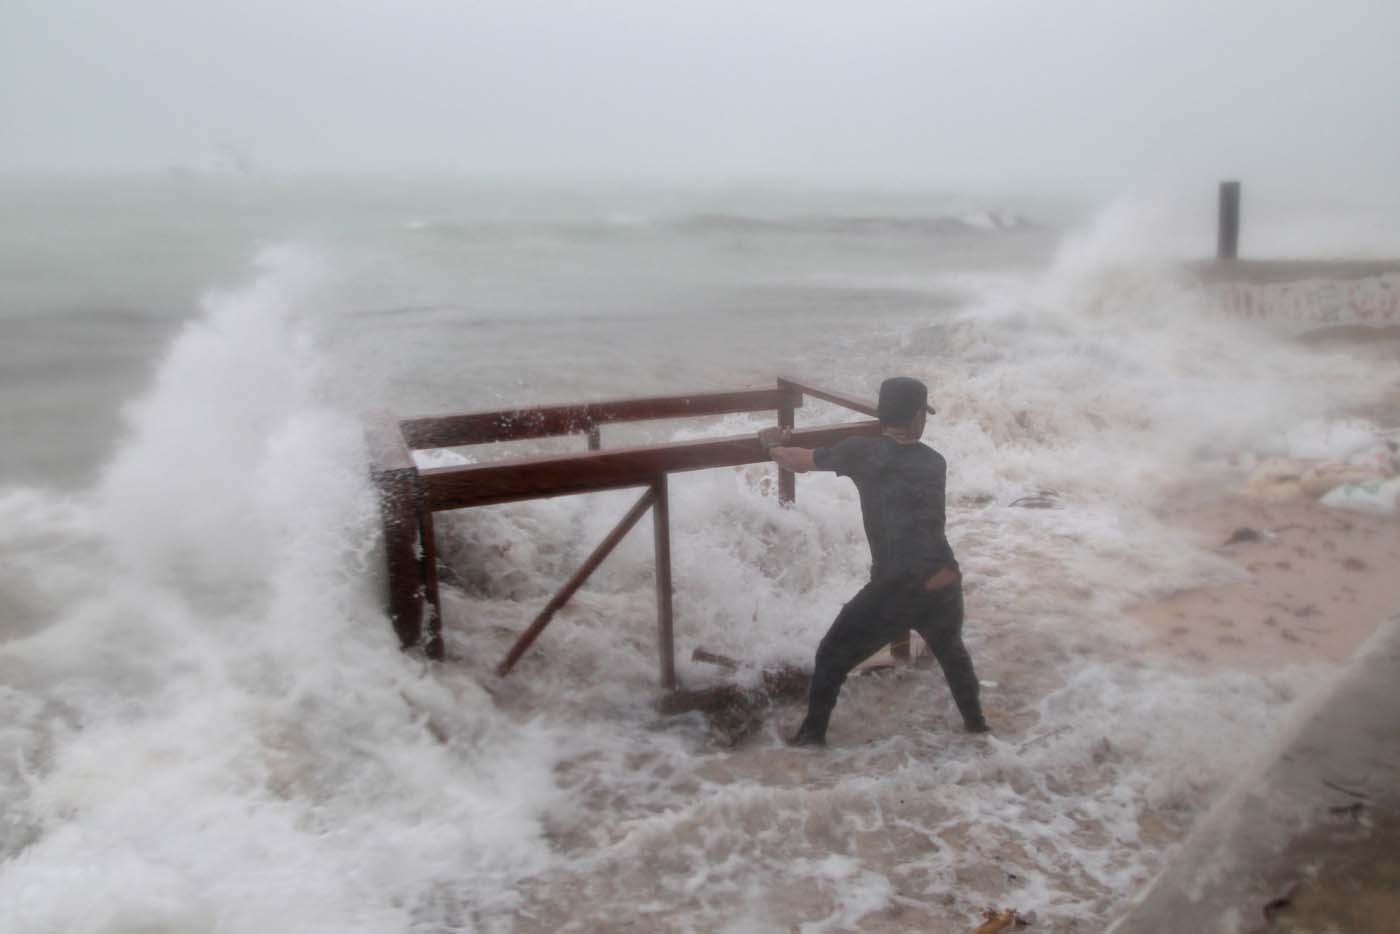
[798,580,986,742]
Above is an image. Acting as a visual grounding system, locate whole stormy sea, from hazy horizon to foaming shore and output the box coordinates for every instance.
[0,178,1393,934]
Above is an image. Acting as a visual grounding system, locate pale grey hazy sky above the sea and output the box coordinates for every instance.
[0,0,1400,196]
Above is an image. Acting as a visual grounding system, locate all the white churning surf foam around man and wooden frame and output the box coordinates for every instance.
[0,205,1376,933]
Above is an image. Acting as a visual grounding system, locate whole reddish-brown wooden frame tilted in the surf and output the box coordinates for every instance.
[365,378,879,689]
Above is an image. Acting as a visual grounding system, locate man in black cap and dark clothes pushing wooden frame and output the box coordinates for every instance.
[759,377,987,746]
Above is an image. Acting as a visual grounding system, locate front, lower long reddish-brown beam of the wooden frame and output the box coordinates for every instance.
[421,421,881,511]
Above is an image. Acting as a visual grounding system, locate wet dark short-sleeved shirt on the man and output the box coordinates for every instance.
[812,435,958,581]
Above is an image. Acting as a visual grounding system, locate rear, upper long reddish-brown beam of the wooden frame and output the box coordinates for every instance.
[403,388,787,448]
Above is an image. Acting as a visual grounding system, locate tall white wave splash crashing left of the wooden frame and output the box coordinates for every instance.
[0,251,553,933]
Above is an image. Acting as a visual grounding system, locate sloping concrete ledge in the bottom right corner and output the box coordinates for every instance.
[1109,615,1400,934]
